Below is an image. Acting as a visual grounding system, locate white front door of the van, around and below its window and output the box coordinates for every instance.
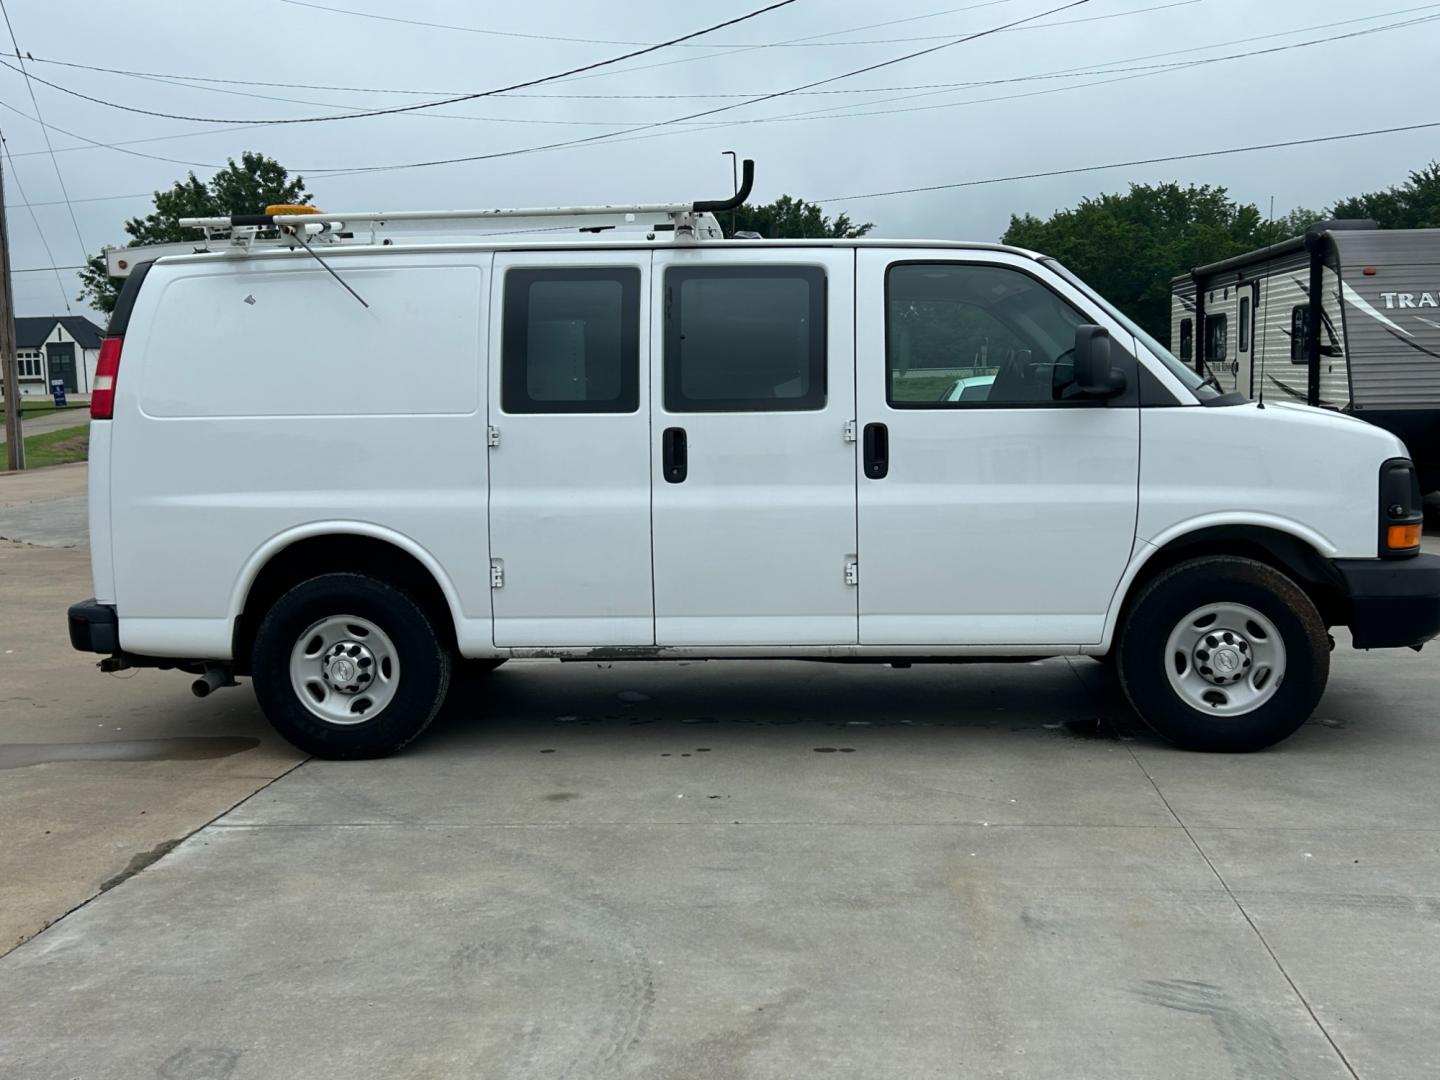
[857,251,1134,647]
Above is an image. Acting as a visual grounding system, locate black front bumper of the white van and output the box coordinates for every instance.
[1335,554,1440,649]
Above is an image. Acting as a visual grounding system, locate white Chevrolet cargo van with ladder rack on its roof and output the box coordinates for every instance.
[69,170,1440,757]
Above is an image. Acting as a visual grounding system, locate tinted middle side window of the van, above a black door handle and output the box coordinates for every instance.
[665,266,827,412]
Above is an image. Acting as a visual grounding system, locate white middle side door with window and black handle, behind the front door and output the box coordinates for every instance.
[649,245,864,645]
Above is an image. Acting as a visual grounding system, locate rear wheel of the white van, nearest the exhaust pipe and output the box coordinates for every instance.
[252,573,452,757]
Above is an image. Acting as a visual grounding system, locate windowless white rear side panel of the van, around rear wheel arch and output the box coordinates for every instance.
[111,252,492,658]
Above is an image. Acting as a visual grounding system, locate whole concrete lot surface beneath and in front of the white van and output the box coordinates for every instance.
[0,469,1440,1080]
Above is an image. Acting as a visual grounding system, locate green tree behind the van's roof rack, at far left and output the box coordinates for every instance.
[78,151,311,312]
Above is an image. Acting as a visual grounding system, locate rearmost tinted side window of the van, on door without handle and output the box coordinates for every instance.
[500,266,639,413]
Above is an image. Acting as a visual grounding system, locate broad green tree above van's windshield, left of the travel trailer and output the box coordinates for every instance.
[1002,183,1320,341]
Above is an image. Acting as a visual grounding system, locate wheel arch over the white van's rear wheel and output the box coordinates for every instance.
[230,521,461,674]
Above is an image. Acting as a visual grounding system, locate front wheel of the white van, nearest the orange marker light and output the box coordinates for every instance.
[1119,556,1331,752]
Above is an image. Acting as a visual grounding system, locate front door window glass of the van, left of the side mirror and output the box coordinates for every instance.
[886,262,1086,409]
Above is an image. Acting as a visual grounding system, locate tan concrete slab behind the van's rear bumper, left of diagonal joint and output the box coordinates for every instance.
[0,464,301,956]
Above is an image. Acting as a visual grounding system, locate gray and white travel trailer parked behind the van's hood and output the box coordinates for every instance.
[1171,220,1440,491]
